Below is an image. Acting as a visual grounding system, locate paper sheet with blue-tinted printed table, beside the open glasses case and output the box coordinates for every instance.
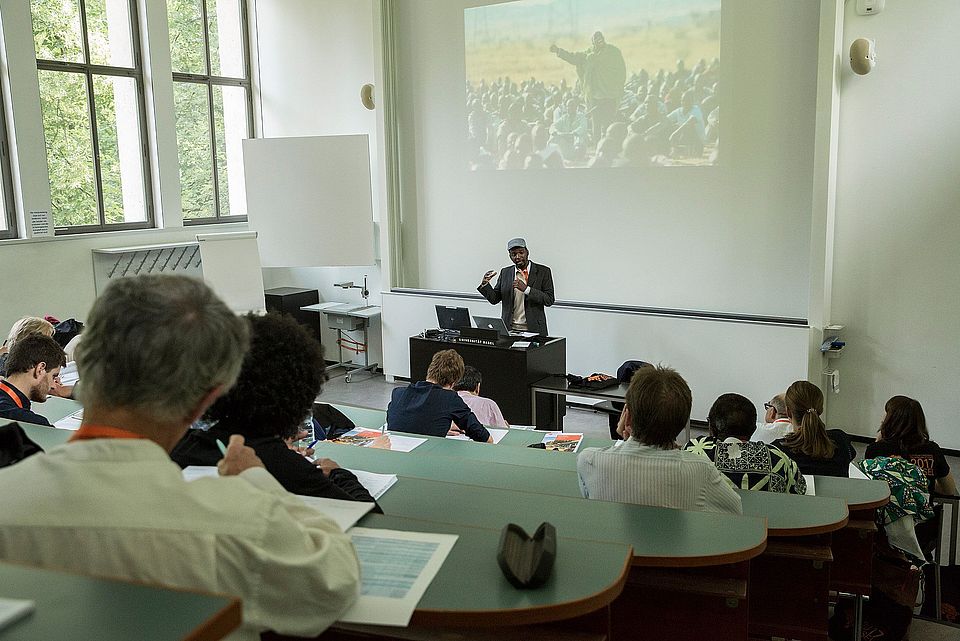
[340,527,457,626]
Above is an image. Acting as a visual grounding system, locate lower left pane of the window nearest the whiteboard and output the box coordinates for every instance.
[173,82,217,219]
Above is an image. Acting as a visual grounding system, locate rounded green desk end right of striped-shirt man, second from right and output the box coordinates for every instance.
[737,487,849,538]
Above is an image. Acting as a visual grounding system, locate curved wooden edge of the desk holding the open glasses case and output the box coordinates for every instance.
[409,545,633,627]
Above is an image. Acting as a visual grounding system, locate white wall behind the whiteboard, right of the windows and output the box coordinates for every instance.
[256,0,385,362]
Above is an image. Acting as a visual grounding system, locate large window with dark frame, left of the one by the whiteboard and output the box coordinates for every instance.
[31,0,153,233]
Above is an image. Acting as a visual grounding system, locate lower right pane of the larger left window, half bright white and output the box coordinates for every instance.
[93,76,147,223]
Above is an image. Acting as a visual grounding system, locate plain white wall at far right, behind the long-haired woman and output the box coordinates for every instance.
[830,0,960,448]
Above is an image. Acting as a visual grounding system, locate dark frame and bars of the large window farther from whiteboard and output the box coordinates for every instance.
[30,0,156,236]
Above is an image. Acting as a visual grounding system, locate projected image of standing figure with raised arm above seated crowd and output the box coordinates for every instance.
[464,0,720,169]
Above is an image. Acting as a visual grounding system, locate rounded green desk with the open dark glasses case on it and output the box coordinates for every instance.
[360,512,630,627]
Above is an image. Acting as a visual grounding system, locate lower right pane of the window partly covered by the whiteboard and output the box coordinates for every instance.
[213,86,250,216]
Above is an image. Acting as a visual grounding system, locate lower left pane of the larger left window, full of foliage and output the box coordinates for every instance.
[38,70,100,227]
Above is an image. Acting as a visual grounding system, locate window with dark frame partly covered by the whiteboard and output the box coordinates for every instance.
[167,0,253,224]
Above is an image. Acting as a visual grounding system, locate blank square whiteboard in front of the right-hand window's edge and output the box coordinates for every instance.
[243,134,374,267]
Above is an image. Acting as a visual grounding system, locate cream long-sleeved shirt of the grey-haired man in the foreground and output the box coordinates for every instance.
[0,439,359,640]
